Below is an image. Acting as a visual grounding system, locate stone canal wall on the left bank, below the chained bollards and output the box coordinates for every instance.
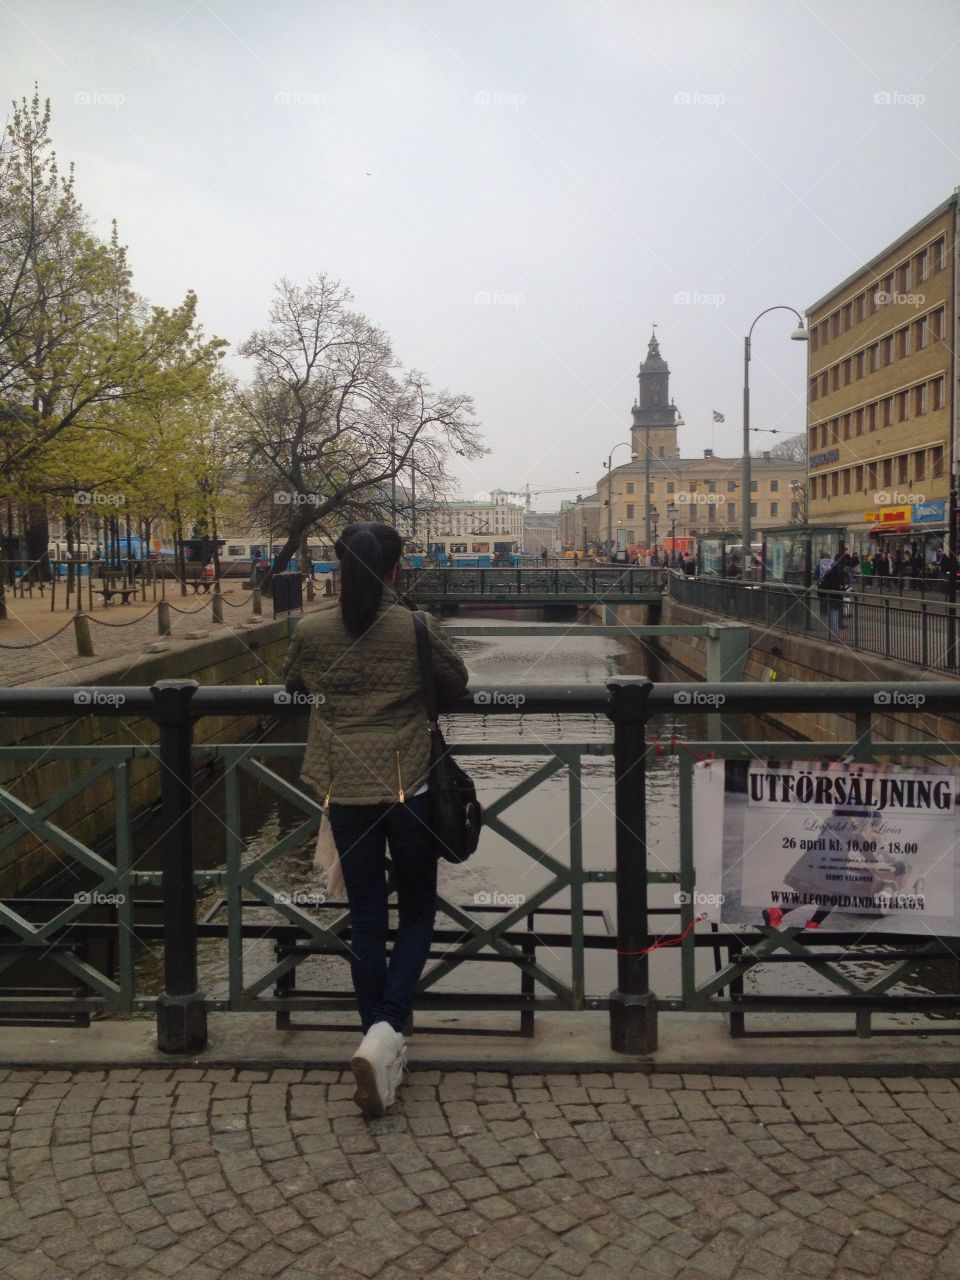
[0,618,304,897]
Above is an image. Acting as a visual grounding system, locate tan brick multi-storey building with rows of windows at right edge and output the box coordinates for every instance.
[806,192,960,547]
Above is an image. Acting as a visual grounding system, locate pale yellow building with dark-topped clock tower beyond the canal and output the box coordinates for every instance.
[570,333,805,549]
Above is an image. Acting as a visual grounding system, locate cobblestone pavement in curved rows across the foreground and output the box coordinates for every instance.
[0,1069,960,1280]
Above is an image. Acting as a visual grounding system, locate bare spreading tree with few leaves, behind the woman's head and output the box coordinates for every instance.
[238,275,485,581]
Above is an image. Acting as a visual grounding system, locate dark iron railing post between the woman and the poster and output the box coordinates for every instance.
[607,680,657,1053]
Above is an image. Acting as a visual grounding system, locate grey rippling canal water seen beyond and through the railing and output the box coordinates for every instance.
[28,609,957,1028]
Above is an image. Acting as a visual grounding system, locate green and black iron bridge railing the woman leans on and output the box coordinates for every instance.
[0,678,960,1053]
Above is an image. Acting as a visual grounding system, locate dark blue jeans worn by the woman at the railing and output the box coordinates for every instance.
[330,794,436,1032]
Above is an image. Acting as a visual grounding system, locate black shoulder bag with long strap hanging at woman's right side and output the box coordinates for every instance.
[413,609,484,863]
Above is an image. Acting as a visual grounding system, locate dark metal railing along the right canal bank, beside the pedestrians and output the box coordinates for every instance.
[668,573,960,672]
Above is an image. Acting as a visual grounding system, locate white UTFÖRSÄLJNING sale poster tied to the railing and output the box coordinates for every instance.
[694,760,960,934]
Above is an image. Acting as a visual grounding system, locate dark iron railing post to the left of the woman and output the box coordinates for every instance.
[151,680,207,1053]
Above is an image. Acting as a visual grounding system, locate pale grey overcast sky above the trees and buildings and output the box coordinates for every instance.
[0,0,960,511]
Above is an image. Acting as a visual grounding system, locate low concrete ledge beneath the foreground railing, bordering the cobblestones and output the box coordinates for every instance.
[0,1011,960,1078]
